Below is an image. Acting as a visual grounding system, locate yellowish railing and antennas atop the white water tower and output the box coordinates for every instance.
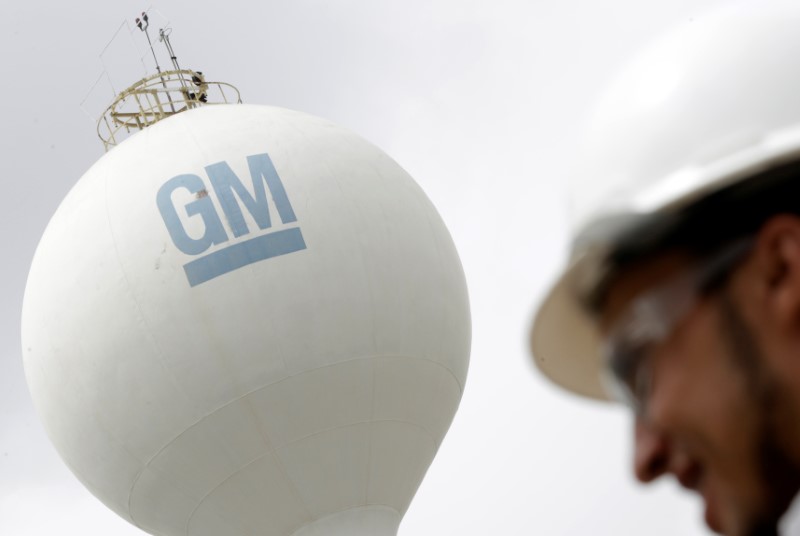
[97,11,242,151]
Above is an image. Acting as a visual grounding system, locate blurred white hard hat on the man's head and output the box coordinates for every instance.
[531,0,800,399]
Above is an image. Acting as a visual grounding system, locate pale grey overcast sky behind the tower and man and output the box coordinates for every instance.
[0,0,715,536]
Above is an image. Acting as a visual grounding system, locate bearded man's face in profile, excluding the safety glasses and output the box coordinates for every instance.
[602,248,800,536]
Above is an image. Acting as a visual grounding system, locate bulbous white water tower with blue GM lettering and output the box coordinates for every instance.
[22,15,470,536]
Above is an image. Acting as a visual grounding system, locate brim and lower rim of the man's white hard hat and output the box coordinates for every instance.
[530,125,800,401]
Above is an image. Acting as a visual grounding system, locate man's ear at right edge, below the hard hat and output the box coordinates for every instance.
[748,214,800,330]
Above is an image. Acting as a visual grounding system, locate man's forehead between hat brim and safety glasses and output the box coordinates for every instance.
[599,250,694,331]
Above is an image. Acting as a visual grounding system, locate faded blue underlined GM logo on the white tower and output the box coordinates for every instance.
[156,153,306,286]
